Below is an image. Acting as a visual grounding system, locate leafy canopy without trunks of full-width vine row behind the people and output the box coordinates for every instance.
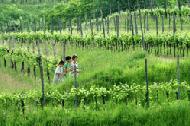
[0,32,190,49]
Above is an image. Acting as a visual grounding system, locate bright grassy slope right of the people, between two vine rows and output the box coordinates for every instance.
[55,44,190,87]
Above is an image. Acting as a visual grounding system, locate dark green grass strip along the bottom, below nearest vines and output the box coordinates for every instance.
[0,101,190,126]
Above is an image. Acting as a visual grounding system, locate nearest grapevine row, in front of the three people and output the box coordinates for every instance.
[0,80,190,107]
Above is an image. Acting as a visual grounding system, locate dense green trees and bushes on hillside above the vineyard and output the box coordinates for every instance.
[0,0,189,31]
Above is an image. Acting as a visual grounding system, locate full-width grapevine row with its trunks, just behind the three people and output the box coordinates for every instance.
[0,32,190,55]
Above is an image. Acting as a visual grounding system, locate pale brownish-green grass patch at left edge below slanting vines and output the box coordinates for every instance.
[0,62,40,92]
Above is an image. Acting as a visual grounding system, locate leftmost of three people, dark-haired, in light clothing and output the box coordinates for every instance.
[53,60,64,83]
